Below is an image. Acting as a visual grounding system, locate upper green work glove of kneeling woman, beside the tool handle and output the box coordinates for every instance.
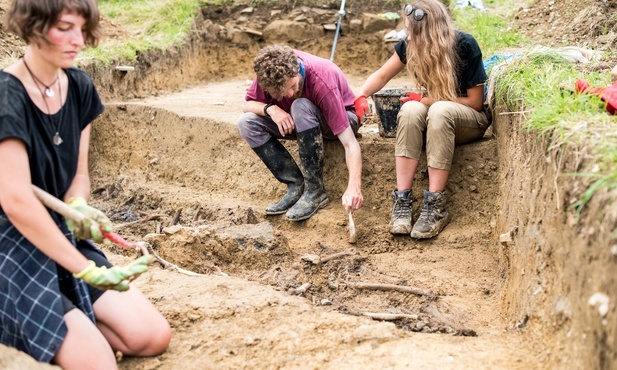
[65,197,112,245]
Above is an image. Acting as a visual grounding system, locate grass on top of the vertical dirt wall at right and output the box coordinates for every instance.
[495,51,617,214]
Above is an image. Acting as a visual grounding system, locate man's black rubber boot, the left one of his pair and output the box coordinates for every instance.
[253,137,304,215]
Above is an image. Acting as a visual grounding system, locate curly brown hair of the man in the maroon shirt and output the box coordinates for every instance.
[253,45,300,99]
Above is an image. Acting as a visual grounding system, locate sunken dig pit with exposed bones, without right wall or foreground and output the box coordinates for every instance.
[80,78,540,368]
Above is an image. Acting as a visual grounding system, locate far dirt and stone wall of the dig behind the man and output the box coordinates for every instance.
[79,1,394,101]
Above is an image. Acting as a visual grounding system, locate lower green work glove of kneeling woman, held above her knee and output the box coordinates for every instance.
[73,254,155,292]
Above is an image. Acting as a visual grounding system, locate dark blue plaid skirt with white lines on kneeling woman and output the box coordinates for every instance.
[0,209,102,362]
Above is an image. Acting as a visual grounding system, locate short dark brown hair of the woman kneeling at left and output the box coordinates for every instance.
[5,0,102,47]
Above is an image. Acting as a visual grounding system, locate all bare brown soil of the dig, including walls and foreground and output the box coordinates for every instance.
[0,1,617,370]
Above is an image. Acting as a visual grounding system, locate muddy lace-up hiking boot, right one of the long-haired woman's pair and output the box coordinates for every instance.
[410,190,450,239]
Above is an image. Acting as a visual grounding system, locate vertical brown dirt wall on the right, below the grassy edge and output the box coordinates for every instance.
[494,107,617,369]
